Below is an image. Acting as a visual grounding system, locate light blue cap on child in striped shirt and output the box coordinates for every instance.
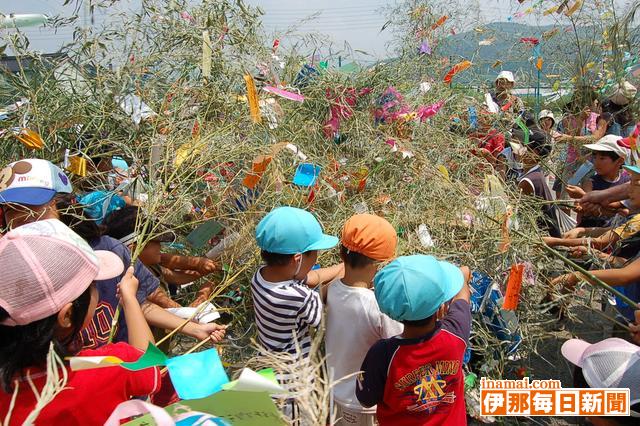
[256,207,338,254]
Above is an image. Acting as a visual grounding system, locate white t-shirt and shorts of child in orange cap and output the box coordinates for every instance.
[325,280,403,413]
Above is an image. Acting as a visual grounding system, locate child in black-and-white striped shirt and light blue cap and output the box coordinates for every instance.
[251,207,340,358]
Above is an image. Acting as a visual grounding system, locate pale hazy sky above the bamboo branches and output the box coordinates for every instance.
[0,0,630,59]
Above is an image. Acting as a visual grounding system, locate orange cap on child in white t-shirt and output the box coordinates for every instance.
[342,214,398,261]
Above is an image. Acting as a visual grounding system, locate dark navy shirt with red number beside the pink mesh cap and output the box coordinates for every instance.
[81,236,160,349]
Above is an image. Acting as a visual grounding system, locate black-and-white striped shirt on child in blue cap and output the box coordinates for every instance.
[251,269,322,358]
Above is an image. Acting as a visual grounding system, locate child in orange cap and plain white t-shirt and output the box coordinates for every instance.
[325,214,402,425]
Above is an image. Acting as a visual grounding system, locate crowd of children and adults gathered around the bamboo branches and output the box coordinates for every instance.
[0,71,640,425]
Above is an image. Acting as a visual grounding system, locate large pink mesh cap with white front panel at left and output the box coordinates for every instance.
[0,219,124,326]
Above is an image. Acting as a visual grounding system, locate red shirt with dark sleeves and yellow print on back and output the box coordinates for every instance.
[356,300,471,426]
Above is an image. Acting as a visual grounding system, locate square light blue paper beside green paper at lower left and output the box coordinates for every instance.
[167,348,229,399]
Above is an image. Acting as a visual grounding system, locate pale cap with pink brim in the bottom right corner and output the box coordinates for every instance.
[561,337,640,405]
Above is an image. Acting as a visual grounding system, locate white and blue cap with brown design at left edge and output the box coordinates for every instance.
[0,159,73,206]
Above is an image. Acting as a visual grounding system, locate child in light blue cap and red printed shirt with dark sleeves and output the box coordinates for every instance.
[356,255,471,425]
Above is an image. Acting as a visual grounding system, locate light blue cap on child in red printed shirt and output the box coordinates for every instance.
[373,254,464,321]
